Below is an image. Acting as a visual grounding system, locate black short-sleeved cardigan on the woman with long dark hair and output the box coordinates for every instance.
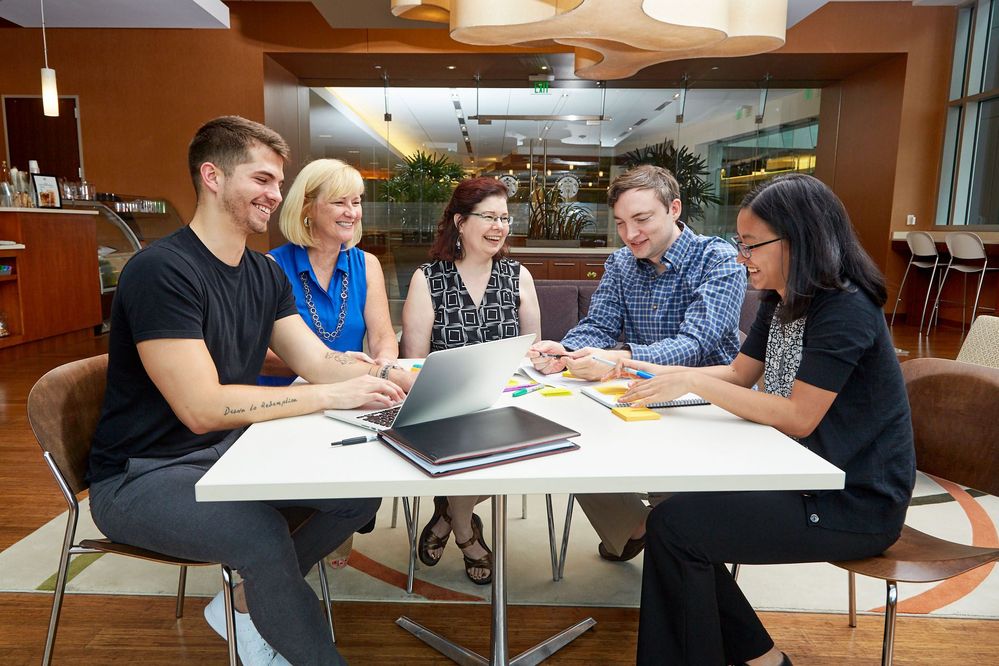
[742,289,916,533]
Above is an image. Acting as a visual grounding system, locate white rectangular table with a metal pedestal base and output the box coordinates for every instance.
[196,391,844,666]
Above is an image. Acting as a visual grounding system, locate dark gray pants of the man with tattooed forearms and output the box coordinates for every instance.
[90,431,381,666]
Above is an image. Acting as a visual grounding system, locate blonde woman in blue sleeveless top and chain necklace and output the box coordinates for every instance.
[259,159,399,568]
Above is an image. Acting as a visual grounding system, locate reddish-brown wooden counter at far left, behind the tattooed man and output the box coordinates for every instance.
[0,208,101,349]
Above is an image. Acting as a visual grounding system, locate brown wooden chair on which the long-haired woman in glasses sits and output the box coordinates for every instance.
[833,358,999,666]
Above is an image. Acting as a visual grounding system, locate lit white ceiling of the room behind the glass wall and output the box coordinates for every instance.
[310,87,804,168]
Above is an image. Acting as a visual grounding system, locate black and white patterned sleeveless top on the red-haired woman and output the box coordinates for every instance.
[420,259,520,351]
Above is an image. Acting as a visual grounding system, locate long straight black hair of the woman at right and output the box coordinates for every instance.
[742,174,888,322]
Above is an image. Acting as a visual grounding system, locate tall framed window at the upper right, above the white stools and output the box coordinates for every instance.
[936,0,999,225]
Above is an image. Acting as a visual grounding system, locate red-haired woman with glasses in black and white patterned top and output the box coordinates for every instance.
[402,178,541,585]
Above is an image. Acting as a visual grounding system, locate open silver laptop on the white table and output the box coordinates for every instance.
[324,334,534,430]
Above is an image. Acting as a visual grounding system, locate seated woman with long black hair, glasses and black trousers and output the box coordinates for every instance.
[608,175,915,666]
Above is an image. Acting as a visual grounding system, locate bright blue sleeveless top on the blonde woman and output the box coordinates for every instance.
[258,243,368,386]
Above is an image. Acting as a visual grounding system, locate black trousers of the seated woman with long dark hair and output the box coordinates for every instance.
[638,491,900,666]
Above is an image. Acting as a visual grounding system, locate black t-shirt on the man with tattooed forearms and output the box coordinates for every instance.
[88,227,298,483]
